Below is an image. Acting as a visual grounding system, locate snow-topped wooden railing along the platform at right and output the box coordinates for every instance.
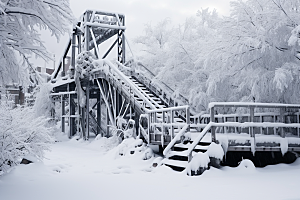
[209,102,300,141]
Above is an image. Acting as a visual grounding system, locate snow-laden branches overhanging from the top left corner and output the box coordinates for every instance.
[0,0,74,83]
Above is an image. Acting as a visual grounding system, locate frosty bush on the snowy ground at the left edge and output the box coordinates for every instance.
[0,103,54,174]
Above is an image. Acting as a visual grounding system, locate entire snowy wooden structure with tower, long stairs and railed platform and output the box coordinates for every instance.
[51,10,300,170]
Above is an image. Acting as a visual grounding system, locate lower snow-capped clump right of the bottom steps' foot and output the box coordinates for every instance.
[186,152,210,176]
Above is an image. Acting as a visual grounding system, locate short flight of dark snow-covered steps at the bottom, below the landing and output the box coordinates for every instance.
[162,141,211,171]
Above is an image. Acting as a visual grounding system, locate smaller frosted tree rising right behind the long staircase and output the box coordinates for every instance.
[137,8,220,110]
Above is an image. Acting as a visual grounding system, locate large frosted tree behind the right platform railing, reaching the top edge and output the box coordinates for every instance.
[205,0,300,103]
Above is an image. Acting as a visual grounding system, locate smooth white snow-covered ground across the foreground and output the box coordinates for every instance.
[0,134,300,200]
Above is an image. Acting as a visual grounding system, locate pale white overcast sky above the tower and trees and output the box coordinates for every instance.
[33,0,230,66]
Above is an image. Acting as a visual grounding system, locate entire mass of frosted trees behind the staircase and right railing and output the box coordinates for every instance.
[136,0,300,111]
